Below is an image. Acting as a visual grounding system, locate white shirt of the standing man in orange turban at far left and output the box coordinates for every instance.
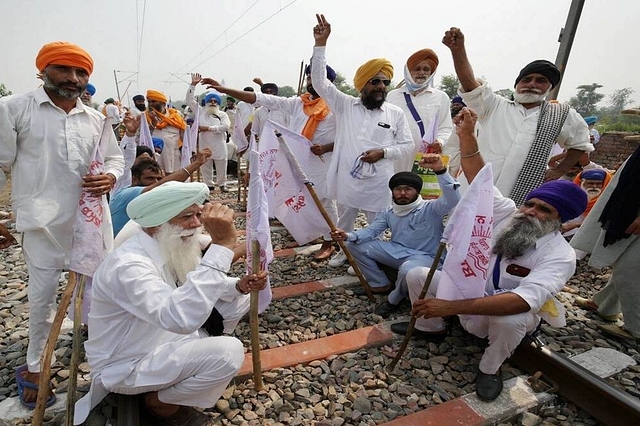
[0,87,124,250]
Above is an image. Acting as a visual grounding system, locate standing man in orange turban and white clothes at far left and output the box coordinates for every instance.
[0,42,125,408]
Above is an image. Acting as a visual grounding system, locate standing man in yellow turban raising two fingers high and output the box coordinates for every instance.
[311,15,414,272]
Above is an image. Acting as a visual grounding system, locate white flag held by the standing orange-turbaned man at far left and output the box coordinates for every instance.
[69,120,114,277]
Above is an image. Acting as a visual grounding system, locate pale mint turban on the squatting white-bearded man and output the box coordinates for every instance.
[127,181,209,228]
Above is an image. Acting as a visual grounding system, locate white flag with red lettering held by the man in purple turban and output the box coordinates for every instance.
[437,164,493,300]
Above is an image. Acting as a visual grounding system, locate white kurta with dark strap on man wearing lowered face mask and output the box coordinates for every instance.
[387,87,453,172]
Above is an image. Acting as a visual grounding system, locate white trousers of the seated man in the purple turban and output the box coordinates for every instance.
[407,267,540,374]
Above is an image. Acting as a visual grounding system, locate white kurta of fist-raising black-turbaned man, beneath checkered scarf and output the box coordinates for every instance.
[460,82,593,195]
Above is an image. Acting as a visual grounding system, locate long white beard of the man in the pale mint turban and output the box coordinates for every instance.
[155,223,203,284]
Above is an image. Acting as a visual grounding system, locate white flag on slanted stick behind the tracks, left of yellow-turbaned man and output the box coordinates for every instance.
[258,120,329,245]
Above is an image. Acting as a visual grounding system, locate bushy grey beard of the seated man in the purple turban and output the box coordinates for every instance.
[492,212,561,259]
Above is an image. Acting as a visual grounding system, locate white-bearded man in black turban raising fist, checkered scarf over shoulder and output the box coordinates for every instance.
[442,28,594,206]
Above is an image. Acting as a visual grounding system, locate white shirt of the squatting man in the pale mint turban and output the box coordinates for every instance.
[85,232,241,380]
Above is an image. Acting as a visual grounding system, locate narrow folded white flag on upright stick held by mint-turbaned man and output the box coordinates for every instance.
[246,150,273,312]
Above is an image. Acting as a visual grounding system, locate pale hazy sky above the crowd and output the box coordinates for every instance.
[0,0,640,105]
